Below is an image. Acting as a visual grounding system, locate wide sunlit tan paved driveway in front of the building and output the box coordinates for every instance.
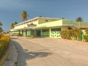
[13,37,88,66]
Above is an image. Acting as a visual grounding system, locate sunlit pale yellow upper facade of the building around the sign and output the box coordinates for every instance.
[15,20,62,29]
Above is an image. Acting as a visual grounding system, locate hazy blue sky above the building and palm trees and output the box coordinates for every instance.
[0,0,88,31]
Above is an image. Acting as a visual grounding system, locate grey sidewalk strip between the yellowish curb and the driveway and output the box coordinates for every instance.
[3,41,18,66]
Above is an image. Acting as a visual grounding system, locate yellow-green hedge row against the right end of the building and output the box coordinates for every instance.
[61,28,88,42]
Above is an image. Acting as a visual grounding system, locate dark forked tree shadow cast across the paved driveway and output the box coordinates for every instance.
[12,40,52,66]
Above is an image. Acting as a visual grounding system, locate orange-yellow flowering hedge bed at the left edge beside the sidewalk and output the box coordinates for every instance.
[0,35,10,58]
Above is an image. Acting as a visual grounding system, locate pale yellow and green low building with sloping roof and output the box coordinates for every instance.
[10,17,88,38]
